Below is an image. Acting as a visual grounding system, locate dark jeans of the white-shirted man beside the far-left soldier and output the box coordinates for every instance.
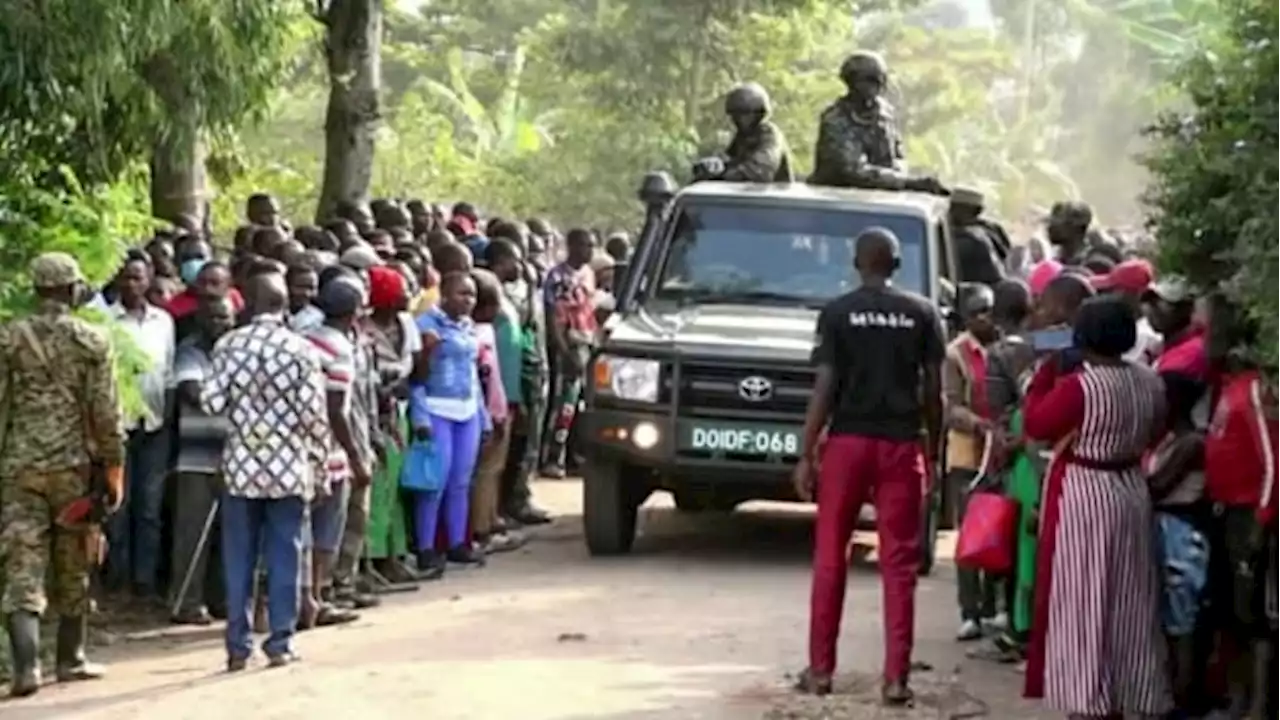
[106,428,168,594]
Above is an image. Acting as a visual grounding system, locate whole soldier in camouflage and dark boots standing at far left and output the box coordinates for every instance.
[0,252,124,697]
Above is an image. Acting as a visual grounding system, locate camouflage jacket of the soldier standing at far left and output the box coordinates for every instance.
[0,301,124,478]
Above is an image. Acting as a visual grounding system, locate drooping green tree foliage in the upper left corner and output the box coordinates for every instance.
[0,0,305,184]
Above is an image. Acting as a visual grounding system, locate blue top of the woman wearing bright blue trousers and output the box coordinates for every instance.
[410,306,492,429]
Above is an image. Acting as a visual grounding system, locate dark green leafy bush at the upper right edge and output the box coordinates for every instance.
[1148,0,1280,366]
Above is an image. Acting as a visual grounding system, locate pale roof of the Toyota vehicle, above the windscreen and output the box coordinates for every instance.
[676,181,948,218]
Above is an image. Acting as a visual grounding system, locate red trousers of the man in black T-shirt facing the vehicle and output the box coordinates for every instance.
[809,434,924,682]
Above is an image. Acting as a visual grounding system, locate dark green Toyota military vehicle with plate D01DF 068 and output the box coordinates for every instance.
[581,174,955,571]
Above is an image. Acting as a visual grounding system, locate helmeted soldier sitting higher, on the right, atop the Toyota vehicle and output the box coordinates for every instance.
[809,51,946,195]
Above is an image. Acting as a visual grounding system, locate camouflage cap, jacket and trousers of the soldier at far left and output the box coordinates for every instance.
[0,254,124,615]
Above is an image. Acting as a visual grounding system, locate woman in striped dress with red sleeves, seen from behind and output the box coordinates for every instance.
[1024,297,1171,719]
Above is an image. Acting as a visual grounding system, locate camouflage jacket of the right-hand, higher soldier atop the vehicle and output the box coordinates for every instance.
[809,96,905,188]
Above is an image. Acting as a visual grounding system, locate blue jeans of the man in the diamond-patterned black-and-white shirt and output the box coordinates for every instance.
[223,493,306,659]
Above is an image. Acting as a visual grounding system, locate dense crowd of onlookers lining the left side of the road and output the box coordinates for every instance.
[0,195,630,694]
